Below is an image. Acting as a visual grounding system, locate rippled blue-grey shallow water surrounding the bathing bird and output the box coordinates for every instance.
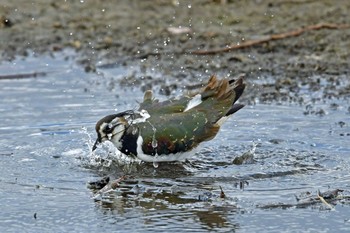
[0,54,350,232]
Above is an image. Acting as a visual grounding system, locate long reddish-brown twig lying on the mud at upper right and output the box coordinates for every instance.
[189,23,350,55]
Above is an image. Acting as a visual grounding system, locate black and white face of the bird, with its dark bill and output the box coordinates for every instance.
[92,115,127,151]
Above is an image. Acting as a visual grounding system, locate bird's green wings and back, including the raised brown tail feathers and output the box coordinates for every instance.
[135,76,245,155]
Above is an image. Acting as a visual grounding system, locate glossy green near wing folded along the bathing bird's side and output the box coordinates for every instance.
[138,112,220,155]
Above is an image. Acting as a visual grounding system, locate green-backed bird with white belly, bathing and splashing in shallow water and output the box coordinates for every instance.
[92,75,246,163]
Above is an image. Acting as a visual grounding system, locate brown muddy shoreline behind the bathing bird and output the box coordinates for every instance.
[0,0,350,104]
